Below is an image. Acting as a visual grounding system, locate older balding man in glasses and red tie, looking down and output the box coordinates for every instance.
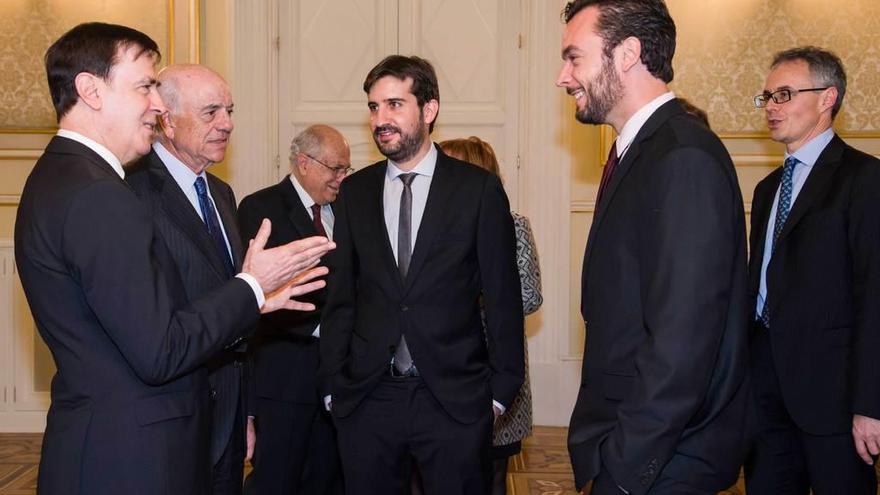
[238,125,353,495]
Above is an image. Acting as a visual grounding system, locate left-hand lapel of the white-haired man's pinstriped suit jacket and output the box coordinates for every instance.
[149,151,227,279]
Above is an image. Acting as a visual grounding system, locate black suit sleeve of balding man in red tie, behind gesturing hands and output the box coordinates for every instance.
[238,196,320,339]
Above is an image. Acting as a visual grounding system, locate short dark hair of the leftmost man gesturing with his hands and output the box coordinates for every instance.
[44,22,162,121]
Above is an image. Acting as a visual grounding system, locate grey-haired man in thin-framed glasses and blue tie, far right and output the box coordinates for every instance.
[745,47,880,495]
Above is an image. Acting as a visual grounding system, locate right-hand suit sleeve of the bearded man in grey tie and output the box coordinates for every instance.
[477,176,525,408]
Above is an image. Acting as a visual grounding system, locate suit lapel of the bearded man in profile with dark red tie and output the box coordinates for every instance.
[583,99,683,278]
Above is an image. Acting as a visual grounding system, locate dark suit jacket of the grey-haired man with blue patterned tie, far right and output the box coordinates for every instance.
[749,136,880,435]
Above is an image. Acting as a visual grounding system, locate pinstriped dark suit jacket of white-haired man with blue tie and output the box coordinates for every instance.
[125,150,245,464]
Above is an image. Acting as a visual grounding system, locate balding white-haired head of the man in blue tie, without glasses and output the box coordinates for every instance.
[159,64,234,174]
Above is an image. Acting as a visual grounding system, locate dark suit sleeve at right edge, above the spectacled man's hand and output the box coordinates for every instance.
[849,158,880,419]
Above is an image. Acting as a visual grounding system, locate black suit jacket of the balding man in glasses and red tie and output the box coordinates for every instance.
[238,176,326,406]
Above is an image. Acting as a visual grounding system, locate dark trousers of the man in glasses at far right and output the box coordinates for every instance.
[745,327,880,495]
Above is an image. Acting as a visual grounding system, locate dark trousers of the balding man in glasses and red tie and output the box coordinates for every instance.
[244,397,344,495]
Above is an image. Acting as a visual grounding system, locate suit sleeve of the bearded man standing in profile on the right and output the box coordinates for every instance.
[601,148,745,493]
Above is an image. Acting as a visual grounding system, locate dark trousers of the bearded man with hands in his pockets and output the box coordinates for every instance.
[334,377,493,495]
